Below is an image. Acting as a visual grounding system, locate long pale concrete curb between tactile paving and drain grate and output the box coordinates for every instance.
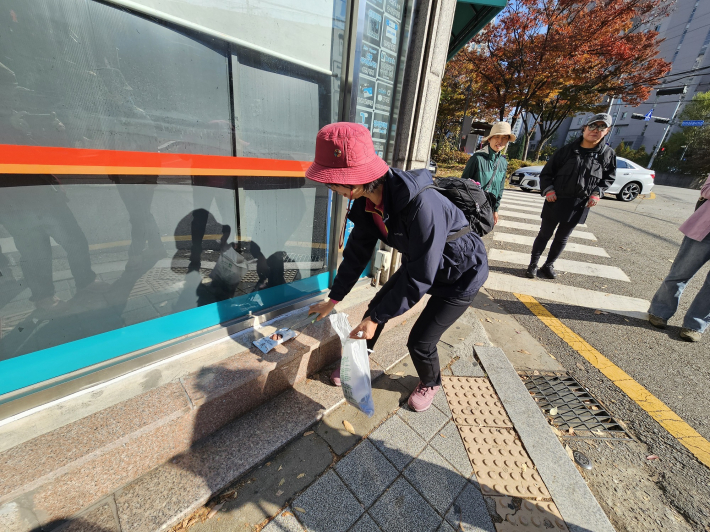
[475,346,614,532]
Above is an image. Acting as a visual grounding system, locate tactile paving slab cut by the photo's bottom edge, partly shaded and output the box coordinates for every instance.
[491,497,569,532]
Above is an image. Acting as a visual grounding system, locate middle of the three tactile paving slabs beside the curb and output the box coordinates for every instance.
[459,426,550,498]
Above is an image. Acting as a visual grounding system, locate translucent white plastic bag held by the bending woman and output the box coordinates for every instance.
[330,312,375,417]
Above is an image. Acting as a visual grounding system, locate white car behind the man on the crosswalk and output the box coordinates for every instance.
[510,157,656,201]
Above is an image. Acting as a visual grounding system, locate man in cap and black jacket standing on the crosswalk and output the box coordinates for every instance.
[525,113,616,279]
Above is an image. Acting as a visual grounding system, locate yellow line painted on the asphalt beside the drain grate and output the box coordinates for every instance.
[513,294,710,467]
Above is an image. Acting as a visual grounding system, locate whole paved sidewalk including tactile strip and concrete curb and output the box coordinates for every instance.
[190,309,613,532]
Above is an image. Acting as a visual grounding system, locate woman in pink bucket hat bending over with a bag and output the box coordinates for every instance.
[306,122,488,412]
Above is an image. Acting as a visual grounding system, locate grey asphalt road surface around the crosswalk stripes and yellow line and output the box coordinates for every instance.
[491,186,710,530]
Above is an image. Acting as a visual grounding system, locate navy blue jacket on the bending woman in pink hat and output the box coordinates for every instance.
[330,168,488,323]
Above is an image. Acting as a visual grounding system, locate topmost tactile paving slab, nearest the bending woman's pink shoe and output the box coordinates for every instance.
[443,377,513,428]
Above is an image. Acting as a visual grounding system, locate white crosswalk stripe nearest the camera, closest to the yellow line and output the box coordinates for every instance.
[483,272,649,320]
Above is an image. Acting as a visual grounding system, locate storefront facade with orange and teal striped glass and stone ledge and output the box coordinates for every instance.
[0,0,505,531]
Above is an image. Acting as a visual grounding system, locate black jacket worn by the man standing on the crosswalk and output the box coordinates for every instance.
[540,138,616,199]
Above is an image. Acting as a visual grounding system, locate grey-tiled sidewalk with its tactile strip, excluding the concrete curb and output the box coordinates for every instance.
[263,377,567,532]
